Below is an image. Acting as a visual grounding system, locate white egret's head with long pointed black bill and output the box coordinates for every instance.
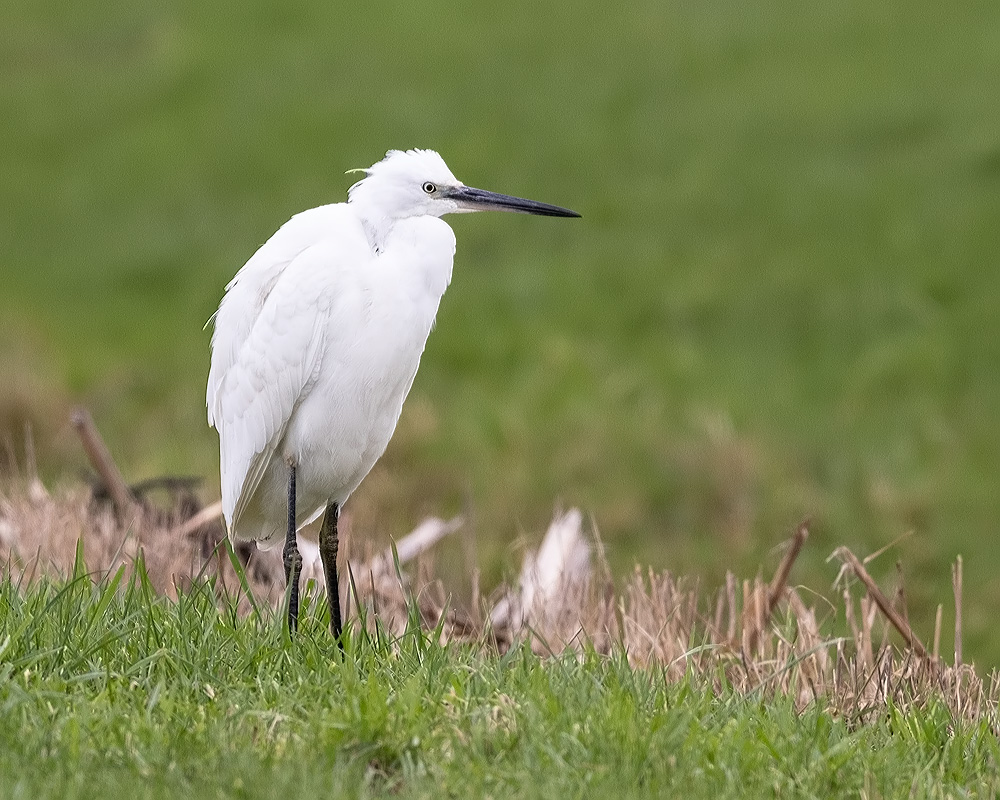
[348,150,580,219]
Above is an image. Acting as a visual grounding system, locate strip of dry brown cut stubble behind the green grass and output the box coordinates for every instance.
[0,468,1000,730]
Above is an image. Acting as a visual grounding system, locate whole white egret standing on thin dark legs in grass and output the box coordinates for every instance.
[207,150,579,640]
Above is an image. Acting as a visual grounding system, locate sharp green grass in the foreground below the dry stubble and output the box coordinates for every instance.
[0,571,1000,798]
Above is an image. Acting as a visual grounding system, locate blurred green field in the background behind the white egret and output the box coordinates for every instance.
[0,0,1000,664]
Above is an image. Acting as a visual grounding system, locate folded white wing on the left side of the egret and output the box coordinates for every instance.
[207,204,370,534]
